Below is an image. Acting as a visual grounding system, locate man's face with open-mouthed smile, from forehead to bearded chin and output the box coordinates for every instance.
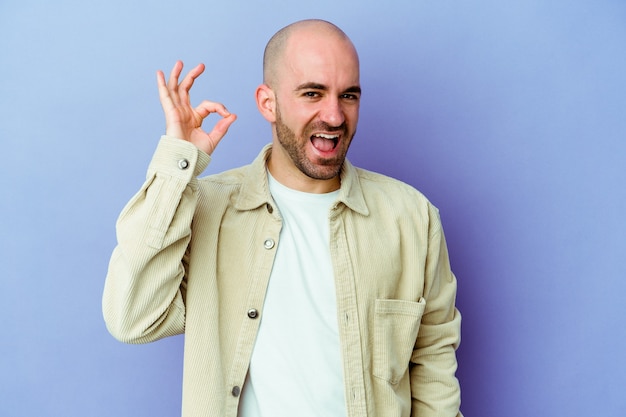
[272,32,361,180]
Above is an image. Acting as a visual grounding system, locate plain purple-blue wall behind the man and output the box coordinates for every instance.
[0,0,626,417]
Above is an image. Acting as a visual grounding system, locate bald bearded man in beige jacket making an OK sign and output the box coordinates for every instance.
[103,20,460,417]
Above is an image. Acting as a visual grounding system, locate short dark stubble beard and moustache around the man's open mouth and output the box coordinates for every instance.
[276,105,352,180]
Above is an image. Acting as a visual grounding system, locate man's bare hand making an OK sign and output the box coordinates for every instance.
[157,61,237,155]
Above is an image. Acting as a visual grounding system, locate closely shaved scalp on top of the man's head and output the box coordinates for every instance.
[263,19,356,88]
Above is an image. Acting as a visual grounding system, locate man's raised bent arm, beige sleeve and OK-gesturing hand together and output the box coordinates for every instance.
[102,61,236,343]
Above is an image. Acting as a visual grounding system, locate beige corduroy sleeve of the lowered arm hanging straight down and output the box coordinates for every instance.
[411,206,462,417]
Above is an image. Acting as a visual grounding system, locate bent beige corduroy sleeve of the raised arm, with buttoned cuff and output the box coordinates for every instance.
[102,136,210,343]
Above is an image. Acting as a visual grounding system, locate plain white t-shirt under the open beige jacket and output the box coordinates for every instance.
[239,173,346,417]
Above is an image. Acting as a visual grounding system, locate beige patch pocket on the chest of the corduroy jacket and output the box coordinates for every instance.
[373,298,426,385]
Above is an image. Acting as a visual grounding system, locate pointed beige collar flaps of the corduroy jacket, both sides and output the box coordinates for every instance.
[235,144,369,216]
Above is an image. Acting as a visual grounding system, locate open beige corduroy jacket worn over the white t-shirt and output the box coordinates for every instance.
[103,136,461,417]
